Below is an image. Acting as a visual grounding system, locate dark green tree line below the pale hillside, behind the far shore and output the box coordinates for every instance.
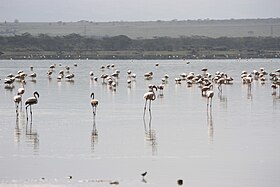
[0,33,280,57]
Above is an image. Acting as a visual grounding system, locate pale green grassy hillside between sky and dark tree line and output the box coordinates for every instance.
[0,18,280,39]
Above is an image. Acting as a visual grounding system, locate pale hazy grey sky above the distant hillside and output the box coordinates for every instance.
[0,0,280,22]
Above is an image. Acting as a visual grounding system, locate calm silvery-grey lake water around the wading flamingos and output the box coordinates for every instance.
[0,59,280,187]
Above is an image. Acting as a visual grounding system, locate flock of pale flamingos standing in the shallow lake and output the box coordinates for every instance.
[4,63,280,121]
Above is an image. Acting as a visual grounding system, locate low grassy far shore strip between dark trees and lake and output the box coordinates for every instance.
[0,50,280,60]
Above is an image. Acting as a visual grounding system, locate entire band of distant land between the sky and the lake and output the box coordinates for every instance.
[0,18,280,60]
